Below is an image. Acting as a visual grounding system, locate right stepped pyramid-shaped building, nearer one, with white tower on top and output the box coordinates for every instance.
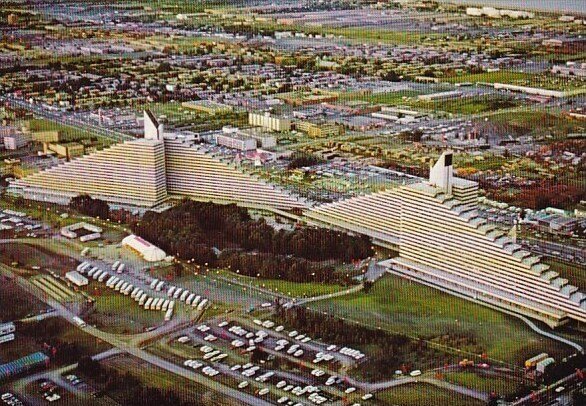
[305,153,586,327]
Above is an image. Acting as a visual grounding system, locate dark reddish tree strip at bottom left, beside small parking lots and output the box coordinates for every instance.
[77,357,201,406]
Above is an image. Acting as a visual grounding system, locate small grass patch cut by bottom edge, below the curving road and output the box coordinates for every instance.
[375,384,484,406]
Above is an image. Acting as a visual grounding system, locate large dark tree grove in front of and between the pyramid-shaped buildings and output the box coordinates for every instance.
[133,199,372,266]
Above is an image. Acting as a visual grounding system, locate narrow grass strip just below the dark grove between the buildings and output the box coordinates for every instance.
[212,270,347,297]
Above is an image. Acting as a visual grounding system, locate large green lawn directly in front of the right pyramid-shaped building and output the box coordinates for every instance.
[310,275,570,366]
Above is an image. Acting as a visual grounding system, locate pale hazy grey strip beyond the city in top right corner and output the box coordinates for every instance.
[439,0,586,14]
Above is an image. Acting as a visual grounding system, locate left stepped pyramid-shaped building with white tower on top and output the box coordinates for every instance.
[9,111,308,210]
